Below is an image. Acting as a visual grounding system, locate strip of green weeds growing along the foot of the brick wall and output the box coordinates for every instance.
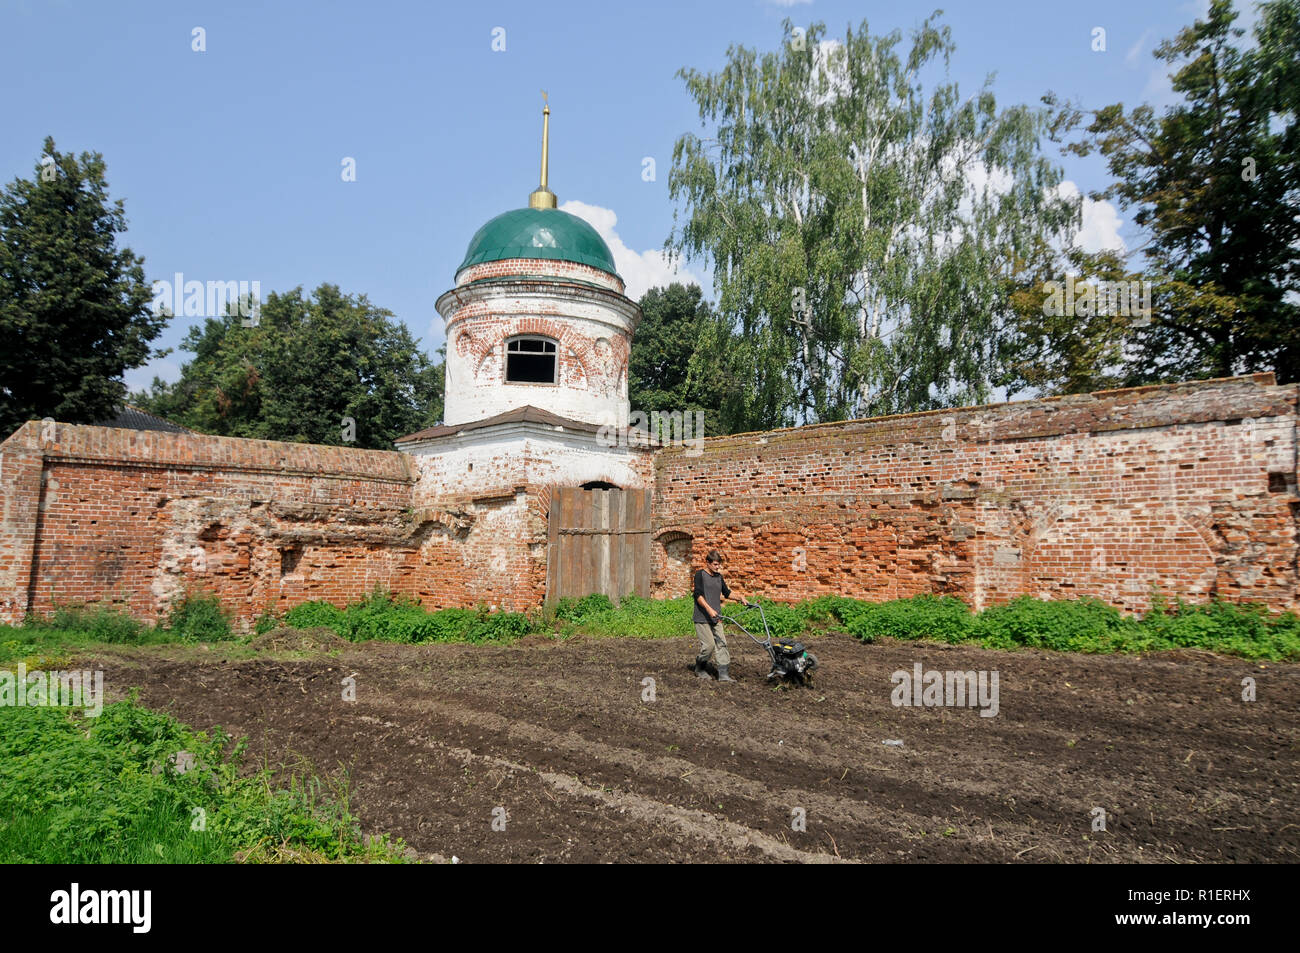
[12,579,1300,668]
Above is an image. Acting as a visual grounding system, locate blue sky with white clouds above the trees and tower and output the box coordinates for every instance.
[0,0,1227,389]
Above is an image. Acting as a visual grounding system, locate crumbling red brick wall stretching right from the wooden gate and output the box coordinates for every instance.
[653,374,1300,610]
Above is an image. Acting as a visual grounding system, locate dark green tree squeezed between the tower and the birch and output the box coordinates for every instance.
[628,282,736,434]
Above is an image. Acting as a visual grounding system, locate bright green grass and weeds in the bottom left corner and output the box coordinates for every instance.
[0,698,403,863]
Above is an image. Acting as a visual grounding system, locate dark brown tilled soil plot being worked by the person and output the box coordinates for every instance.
[86,634,1300,863]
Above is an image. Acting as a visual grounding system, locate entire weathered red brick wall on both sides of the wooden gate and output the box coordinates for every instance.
[0,376,1300,627]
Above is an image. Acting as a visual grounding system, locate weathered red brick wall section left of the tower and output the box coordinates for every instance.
[0,421,426,625]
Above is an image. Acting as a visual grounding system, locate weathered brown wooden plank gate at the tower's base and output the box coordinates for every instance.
[546,486,650,605]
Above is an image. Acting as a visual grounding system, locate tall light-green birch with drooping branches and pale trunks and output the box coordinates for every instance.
[667,17,1079,428]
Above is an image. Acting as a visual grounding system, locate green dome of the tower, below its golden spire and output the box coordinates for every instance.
[456,208,619,277]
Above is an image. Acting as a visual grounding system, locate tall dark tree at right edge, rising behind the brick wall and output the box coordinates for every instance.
[1047,0,1300,384]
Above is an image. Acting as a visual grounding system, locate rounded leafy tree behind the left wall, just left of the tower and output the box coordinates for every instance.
[135,285,443,450]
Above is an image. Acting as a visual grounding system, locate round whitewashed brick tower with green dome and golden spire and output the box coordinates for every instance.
[397,105,653,607]
